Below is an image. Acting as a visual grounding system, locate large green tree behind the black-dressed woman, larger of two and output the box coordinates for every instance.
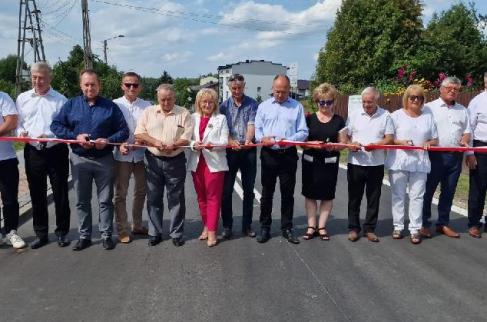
[313,0,423,92]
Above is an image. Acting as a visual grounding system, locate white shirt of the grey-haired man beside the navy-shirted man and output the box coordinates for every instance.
[17,88,67,149]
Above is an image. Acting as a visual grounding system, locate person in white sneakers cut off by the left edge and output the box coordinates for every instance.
[0,92,25,248]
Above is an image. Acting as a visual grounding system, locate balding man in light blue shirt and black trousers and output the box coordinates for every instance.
[255,75,308,244]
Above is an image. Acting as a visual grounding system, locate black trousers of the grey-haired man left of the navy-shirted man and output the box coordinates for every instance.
[24,144,71,238]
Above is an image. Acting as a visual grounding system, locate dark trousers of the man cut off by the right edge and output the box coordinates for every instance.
[468,140,487,228]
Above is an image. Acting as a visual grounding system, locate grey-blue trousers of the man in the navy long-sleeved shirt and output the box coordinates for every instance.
[71,153,115,239]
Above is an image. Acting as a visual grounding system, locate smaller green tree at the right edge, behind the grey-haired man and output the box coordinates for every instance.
[411,3,487,87]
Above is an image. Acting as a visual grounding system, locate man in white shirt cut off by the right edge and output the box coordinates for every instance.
[465,72,487,238]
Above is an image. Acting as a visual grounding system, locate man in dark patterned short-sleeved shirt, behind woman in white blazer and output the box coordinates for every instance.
[220,74,258,239]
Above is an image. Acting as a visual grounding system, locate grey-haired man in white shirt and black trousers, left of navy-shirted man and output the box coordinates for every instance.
[17,62,71,249]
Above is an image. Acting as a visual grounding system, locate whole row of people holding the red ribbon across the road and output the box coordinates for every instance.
[0,62,487,251]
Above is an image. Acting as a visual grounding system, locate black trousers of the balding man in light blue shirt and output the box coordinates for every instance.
[260,147,298,229]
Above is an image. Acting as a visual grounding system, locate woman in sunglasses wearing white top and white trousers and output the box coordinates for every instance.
[385,85,438,244]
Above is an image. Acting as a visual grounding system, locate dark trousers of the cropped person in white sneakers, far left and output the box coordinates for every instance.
[0,158,19,234]
